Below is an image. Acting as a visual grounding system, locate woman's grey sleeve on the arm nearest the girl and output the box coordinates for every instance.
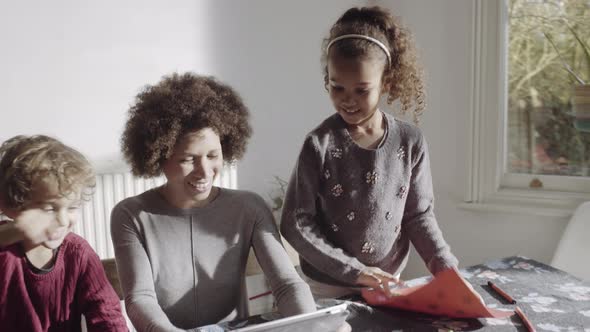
[247,196,316,317]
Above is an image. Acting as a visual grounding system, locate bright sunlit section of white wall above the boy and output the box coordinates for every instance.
[0,0,215,165]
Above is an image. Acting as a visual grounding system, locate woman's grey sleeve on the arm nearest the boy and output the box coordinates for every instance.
[111,205,183,332]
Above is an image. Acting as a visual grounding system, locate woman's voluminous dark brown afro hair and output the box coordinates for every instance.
[121,73,252,178]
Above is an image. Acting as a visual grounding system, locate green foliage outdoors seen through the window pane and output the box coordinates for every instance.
[507,0,590,176]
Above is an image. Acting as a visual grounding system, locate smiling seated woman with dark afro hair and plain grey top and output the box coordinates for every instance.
[111,73,315,332]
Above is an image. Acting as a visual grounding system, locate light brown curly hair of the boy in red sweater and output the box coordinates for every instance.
[0,135,96,210]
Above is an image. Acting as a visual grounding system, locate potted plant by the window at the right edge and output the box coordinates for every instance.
[544,22,590,132]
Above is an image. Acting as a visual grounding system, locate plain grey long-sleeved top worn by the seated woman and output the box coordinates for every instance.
[111,188,315,332]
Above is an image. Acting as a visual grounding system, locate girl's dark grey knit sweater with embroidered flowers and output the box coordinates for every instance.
[281,113,458,285]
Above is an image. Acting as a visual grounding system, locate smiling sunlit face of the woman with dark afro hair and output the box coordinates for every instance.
[163,128,223,208]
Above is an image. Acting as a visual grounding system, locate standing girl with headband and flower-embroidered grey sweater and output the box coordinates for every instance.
[281,7,458,297]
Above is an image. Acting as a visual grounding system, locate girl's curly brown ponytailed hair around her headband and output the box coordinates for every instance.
[322,6,426,123]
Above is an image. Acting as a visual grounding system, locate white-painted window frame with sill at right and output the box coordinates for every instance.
[468,0,590,217]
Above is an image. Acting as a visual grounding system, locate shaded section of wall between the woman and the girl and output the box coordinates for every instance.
[201,0,364,198]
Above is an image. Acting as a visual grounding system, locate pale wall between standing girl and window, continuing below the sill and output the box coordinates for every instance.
[379,0,566,276]
